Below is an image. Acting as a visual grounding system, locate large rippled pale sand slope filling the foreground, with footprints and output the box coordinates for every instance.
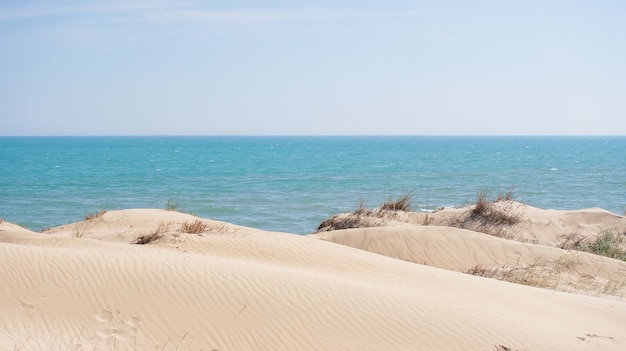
[0,210,626,351]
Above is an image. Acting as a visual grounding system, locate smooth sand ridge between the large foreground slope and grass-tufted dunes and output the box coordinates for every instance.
[312,225,626,300]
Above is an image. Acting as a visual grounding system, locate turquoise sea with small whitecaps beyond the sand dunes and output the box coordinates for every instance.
[0,136,626,234]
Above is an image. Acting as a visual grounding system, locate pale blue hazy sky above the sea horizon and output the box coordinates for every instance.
[0,0,626,136]
